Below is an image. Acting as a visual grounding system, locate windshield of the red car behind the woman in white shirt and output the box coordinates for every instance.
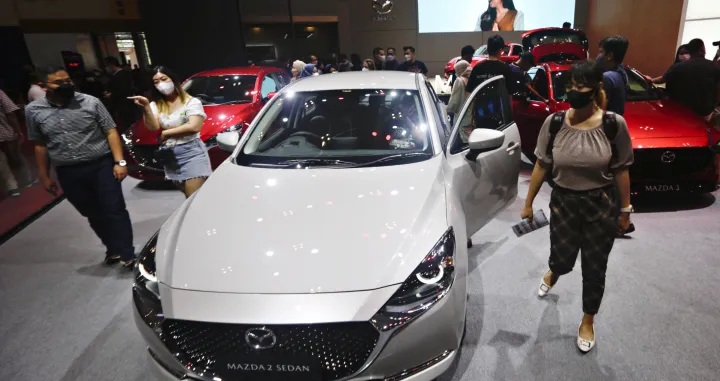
[183,75,257,106]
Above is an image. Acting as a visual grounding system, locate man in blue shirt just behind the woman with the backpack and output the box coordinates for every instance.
[596,36,630,115]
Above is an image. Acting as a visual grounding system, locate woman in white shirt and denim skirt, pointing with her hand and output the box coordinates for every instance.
[130,66,212,197]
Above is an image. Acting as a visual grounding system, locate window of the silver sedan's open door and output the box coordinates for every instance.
[450,78,513,154]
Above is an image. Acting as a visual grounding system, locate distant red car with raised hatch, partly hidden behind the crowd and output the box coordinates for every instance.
[445,28,588,78]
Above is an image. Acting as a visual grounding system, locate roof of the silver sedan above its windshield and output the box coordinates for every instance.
[288,71,424,91]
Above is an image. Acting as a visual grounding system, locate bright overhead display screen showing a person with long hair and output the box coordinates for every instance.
[418,0,575,33]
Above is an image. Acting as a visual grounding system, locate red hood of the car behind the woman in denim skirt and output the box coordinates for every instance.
[130,103,255,144]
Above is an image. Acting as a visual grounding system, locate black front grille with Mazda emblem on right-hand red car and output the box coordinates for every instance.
[630,147,715,180]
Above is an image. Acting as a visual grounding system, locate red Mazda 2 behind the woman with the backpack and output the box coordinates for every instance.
[513,62,720,193]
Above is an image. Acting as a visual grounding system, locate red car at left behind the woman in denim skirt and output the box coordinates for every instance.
[123,66,290,180]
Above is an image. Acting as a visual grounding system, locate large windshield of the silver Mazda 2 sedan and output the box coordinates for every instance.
[236,89,432,168]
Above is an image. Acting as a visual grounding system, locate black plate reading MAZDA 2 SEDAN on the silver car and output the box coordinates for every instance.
[214,353,322,381]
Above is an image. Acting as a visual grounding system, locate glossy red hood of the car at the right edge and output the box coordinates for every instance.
[623,100,708,148]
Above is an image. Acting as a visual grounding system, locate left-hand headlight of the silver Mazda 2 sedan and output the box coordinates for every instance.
[133,232,165,330]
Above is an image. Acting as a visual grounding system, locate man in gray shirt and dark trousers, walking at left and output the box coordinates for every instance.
[25,67,135,268]
